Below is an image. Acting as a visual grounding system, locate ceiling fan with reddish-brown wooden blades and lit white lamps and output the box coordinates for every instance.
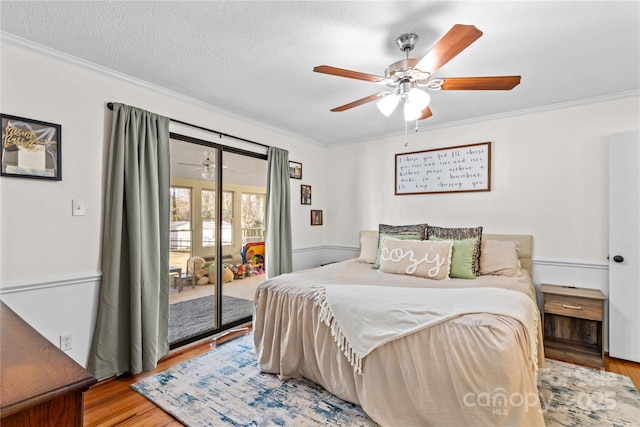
[313,24,520,121]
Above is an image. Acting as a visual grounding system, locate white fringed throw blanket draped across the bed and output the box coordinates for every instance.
[314,284,539,374]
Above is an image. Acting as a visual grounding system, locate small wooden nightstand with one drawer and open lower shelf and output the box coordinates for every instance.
[540,284,607,368]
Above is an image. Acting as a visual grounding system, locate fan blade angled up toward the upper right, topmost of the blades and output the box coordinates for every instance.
[414,24,482,74]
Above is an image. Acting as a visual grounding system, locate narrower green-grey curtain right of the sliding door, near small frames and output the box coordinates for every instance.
[265,147,293,278]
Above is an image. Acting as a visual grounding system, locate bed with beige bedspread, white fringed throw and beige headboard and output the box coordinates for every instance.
[253,231,544,426]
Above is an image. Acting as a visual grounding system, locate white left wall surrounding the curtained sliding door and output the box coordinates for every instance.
[0,35,325,365]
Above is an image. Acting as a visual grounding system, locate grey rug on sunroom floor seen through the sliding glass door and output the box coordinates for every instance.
[169,295,253,343]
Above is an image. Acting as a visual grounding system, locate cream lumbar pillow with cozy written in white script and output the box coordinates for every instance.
[380,236,453,280]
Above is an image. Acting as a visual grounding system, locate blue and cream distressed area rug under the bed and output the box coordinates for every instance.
[131,335,640,427]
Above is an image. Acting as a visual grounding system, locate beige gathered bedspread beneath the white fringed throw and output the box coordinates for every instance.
[254,261,544,427]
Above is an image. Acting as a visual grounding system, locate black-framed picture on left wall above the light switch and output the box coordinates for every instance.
[0,114,62,181]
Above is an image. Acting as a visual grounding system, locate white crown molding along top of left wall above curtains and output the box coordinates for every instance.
[0,31,325,146]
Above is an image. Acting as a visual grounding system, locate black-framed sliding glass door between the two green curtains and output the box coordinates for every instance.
[169,135,267,348]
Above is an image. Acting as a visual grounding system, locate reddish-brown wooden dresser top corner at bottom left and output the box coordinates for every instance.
[0,301,96,427]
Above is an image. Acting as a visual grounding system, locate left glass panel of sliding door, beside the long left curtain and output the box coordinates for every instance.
[169,138,220,348]
